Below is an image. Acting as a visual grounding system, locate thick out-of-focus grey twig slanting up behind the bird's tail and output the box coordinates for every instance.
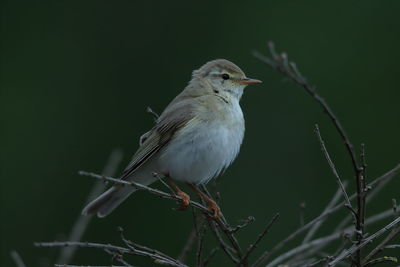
[56,149,122,264]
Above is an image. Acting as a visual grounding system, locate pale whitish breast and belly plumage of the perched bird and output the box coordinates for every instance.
[159,101,244,184]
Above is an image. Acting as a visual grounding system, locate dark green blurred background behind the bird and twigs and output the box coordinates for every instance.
[0,0,400,266]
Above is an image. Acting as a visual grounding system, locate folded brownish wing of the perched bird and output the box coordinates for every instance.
[121,101,197,179]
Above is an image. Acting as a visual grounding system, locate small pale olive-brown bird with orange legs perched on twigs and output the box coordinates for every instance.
[82,59,261,218]
